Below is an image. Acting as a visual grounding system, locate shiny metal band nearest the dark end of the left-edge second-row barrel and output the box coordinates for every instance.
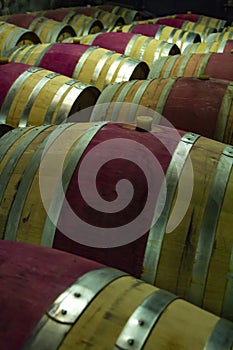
[43,79,77,124]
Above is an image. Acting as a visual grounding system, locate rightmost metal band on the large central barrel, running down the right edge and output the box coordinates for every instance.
[188,146,233,306]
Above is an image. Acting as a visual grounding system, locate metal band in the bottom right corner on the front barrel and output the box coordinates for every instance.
[203,318,233,350]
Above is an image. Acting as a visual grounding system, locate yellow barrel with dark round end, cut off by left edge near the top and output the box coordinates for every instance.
[0,22,41,56]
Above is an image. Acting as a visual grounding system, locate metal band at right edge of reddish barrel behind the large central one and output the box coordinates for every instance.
[214,83,233,142]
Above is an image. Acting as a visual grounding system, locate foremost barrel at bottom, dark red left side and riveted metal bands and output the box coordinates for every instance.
[0,242,233,350]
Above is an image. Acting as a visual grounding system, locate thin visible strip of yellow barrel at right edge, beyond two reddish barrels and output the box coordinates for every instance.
[181,40,233,54]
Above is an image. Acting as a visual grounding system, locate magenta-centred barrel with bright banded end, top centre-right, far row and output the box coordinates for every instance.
[109,24,201,51]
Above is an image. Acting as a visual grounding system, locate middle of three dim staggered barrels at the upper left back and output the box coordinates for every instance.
[36,8,104,36]
